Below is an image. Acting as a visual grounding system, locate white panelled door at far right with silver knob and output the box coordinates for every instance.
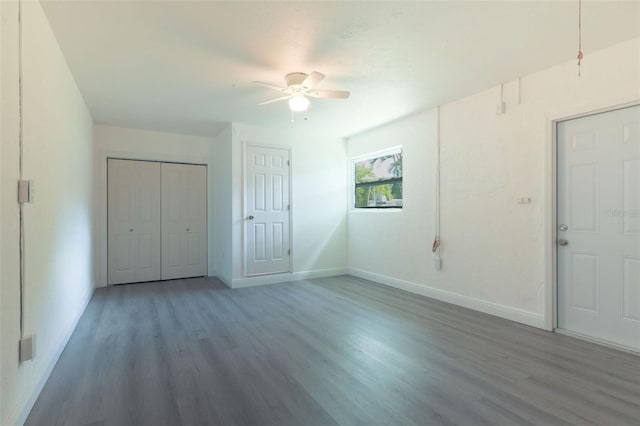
[557,106,640,350]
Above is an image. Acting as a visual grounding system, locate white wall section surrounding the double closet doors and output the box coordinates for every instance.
[93,124,215,286]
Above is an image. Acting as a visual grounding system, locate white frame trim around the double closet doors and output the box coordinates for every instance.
[93,149,213,287]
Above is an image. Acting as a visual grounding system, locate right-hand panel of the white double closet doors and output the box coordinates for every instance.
[161,163,207,280]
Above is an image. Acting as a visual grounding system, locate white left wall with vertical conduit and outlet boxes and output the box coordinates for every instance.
[0,2,93,425]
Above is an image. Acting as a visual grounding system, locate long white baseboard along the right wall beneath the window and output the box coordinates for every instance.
[349,268,546,330]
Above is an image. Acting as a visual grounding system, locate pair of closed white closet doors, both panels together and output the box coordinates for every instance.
[107,159,207,284]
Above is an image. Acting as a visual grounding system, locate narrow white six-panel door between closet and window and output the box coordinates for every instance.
[244,146,290,275]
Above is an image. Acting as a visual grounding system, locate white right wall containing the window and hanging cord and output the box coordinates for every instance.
[348,39,640,328]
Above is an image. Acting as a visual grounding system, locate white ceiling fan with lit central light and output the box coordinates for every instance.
[254,71,349,111]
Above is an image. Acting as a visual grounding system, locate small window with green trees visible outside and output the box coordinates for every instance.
[353,147,402,209]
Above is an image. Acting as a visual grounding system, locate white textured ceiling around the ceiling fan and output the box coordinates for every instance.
[41,0,640,136]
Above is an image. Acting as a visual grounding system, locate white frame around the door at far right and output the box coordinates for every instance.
[543,97,640,334]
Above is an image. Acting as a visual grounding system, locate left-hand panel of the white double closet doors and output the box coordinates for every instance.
[107,159,160,284]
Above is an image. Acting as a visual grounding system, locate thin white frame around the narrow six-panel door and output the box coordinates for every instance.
[241,142,295,278]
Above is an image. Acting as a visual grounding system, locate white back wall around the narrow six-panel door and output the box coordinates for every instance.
[232,123,347,287]
